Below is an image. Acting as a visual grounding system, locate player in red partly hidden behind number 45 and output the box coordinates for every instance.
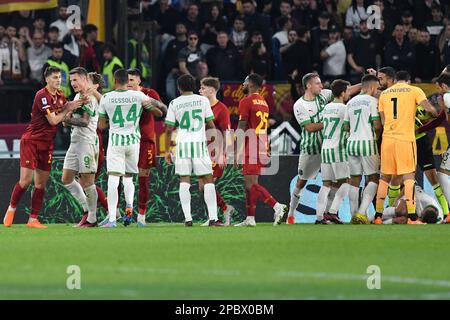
[199,77,235,226]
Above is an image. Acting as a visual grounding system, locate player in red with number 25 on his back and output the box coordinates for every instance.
[235,73,288,227]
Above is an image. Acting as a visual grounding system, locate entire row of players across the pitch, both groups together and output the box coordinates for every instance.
[4,62,450,228]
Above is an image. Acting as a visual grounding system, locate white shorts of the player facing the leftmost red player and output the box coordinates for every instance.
[63,141,99,173]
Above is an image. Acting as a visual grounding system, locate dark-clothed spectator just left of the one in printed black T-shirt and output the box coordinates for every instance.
[164,22,188,100]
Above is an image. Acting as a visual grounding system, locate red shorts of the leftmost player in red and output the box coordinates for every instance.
[20,139,53,172]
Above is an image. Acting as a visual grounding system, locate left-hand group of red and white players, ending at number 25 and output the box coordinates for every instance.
[3,67,288,228]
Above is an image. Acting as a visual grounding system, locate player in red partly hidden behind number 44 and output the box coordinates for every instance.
[124,69,167,227]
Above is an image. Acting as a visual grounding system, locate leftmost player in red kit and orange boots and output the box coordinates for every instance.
[3,67,85,229]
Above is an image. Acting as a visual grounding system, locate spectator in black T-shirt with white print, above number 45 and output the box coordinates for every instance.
[178,30,206,78]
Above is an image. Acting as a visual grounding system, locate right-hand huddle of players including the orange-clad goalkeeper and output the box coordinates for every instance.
[287,67,450,224]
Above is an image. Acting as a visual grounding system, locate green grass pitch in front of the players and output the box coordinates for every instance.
[0,224,450,299]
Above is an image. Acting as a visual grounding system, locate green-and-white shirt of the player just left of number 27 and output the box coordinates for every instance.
[294,89,333,155]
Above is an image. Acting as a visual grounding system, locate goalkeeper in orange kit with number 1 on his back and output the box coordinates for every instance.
[374,72,437,224]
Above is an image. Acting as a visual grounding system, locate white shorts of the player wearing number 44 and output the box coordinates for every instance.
[106,143,139,174]
